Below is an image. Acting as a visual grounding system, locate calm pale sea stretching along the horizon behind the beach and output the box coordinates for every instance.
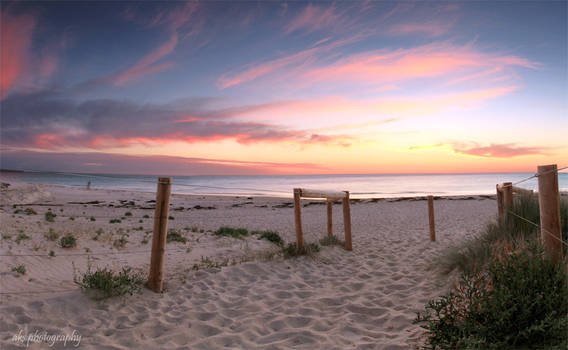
[2,172,568,198]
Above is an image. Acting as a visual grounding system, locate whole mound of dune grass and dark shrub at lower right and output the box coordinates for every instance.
[414,195,568,349]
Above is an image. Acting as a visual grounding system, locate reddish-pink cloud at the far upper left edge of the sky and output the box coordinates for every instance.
[0,9,36,98]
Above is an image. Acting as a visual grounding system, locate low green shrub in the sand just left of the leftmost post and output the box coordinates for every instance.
[73,262,144,300]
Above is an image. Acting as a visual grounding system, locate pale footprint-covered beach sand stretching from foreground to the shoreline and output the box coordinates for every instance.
[0,179,497,349]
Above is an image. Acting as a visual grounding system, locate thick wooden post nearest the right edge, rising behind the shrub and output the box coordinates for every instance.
[537,164,562,261]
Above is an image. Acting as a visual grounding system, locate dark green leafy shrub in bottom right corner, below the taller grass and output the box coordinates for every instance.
[414,242,568,349]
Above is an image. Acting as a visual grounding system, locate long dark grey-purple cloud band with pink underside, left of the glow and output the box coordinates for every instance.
[0,90,344,149]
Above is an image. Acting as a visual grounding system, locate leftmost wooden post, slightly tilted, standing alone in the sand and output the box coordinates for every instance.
[148,177,172,293]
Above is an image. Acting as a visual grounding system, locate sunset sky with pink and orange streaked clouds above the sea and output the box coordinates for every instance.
[0,1,568,175]
